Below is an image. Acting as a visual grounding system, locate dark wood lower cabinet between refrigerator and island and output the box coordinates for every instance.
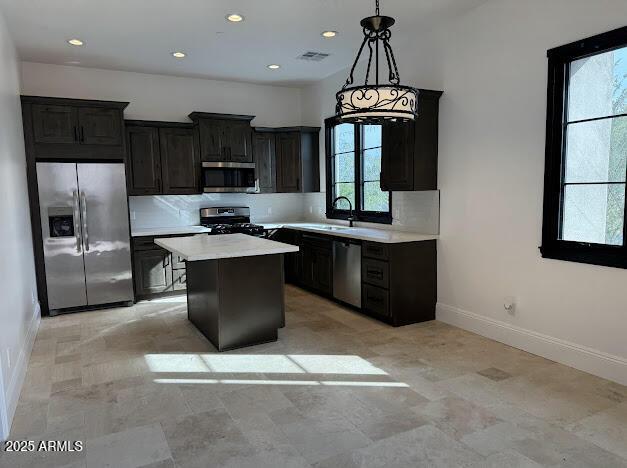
[133,236,187,300]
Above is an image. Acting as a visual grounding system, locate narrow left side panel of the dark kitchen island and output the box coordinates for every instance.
[187,260,220,348]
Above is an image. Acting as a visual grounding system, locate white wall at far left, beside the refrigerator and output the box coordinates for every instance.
[0,9,39,439]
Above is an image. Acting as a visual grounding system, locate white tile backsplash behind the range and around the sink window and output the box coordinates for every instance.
[129,190,440,234]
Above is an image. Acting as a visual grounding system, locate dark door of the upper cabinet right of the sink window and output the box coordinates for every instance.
[381,122,415,191]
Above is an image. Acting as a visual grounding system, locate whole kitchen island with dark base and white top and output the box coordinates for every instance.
[155,234,299,351]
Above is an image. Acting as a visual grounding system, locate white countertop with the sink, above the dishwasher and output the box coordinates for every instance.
[261,222,439,244]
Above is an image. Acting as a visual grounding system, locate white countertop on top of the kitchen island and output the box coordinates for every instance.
[155,234,298,262]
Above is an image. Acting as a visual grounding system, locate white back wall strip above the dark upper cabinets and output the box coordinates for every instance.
[22,62,301,127]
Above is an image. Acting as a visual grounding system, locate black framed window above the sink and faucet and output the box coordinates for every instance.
[325,119,392,224]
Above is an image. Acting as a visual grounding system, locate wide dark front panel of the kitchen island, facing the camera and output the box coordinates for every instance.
[218,254,284,351]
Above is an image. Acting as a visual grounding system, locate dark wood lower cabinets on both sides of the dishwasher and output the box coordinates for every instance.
[271,229,437,327]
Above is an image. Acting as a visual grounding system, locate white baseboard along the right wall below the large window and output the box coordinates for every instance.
[436,303,627,385]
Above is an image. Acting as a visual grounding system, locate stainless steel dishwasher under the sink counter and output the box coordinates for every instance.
[333,239,361,307]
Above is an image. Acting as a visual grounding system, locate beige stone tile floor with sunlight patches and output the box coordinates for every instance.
[0,287,627,468]
